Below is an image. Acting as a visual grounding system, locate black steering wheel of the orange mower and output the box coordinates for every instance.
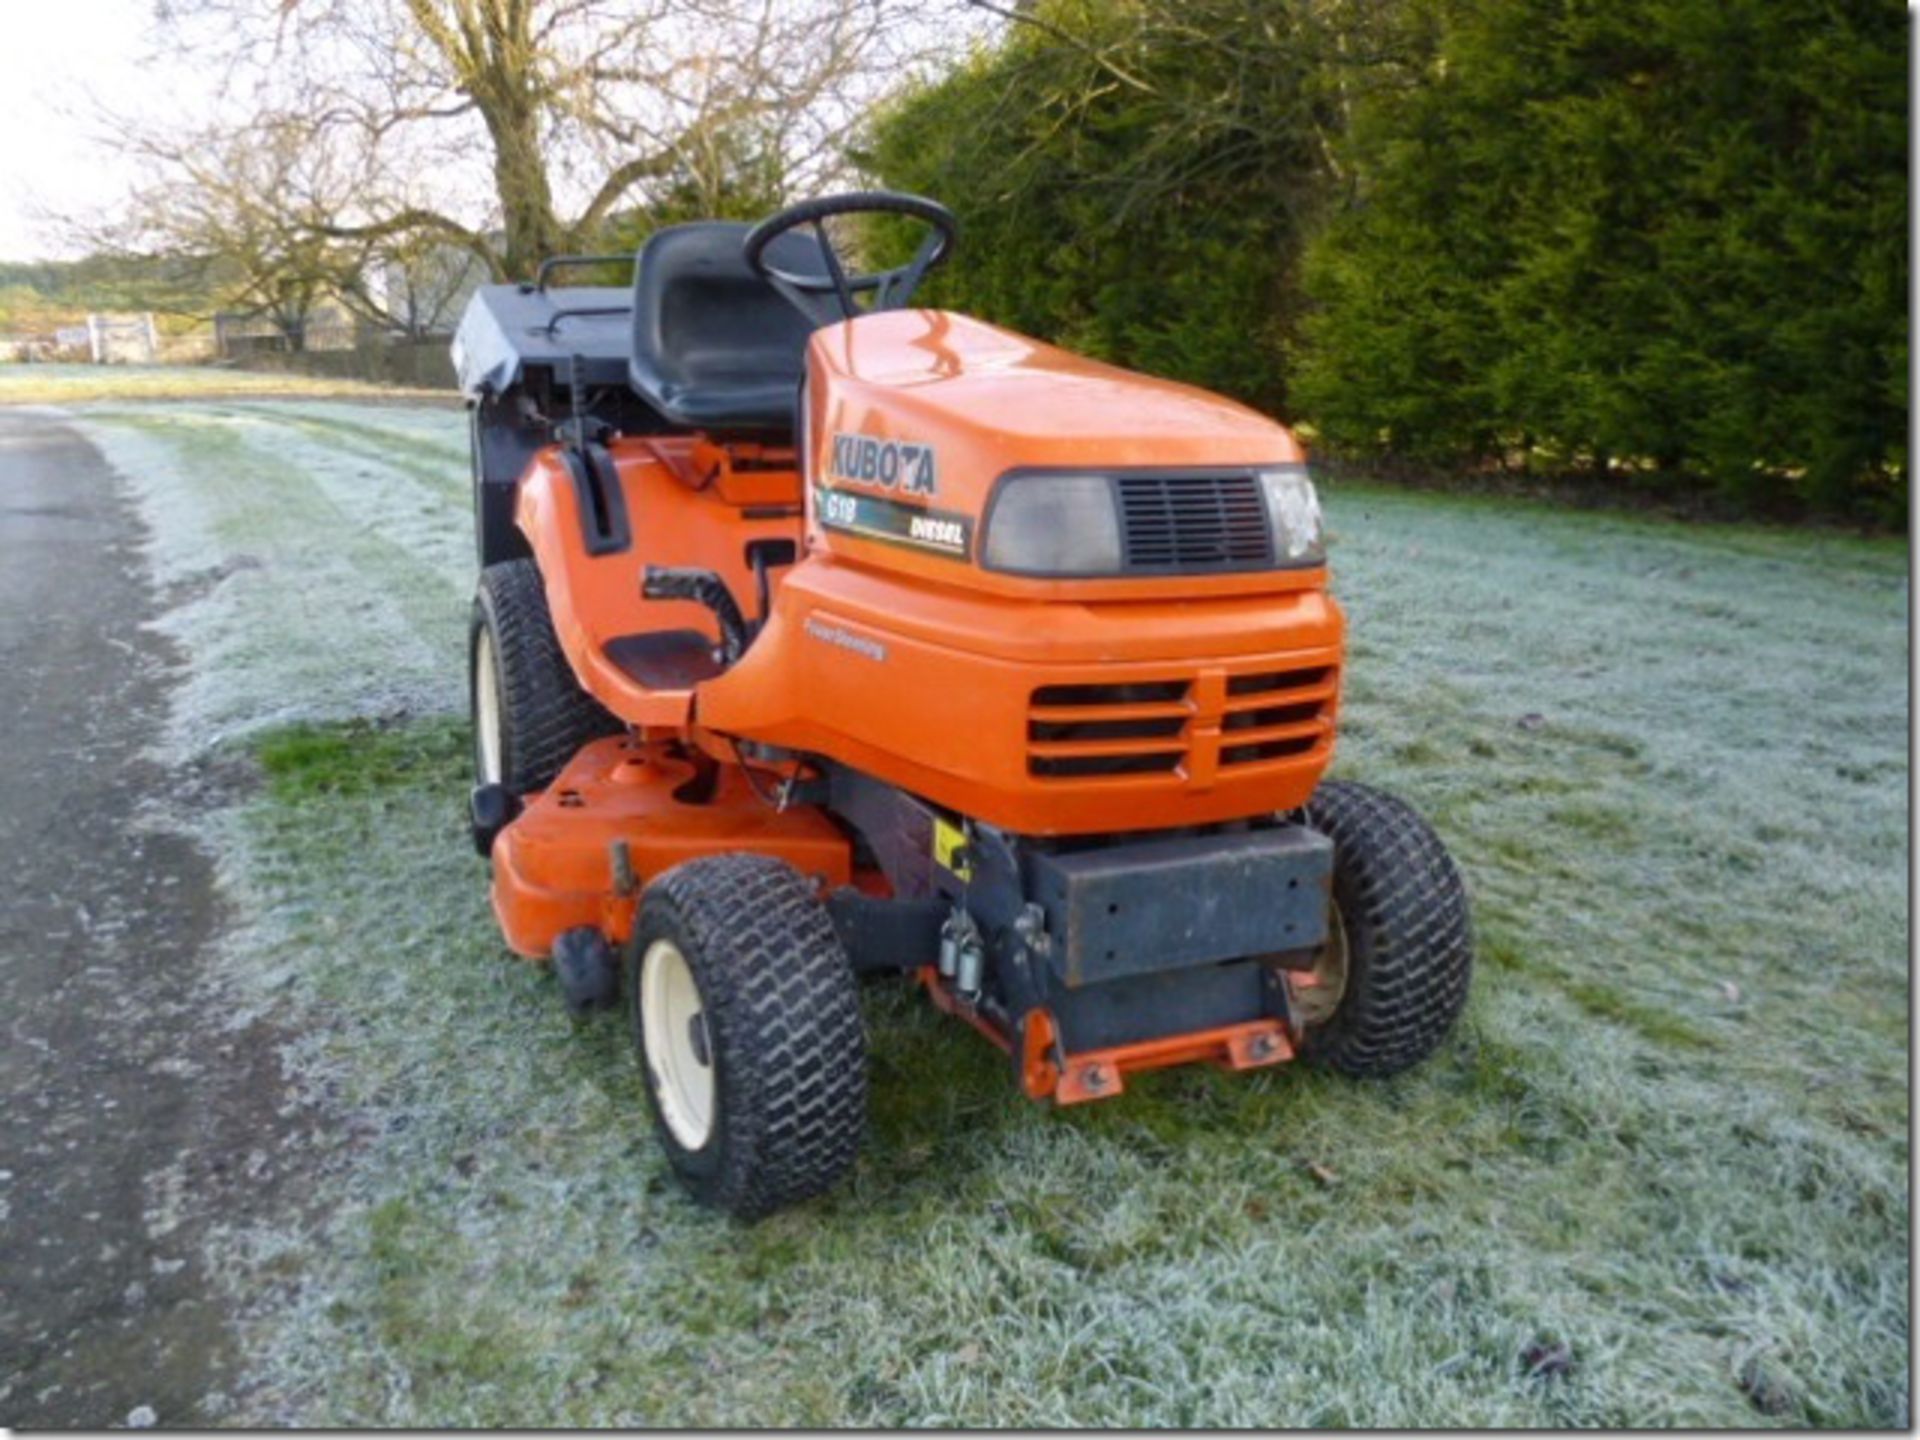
[743,190,960,324]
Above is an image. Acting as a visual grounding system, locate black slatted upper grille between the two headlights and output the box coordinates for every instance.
[1117,474,1273,574]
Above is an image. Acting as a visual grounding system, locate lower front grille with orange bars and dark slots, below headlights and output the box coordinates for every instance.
[1027,664,1338,780]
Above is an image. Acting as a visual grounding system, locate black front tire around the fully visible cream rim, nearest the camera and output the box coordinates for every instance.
[626,854,866,1219]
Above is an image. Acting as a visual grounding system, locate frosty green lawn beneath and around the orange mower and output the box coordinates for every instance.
[100,405,1910,1427]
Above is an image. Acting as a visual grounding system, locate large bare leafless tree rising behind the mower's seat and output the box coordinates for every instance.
[142,0,966,276]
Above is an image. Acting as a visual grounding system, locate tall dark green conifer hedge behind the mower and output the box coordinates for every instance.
[862,0,1908,522]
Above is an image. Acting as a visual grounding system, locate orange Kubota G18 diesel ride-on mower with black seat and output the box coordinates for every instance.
[455,192,1471,1217]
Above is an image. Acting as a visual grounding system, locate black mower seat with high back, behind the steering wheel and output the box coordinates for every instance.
[628,221,822,432]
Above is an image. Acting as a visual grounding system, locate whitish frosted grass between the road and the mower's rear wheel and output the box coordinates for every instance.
[79,403,472,758]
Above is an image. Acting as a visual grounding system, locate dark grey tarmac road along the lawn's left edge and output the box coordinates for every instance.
[0,409,314,1428]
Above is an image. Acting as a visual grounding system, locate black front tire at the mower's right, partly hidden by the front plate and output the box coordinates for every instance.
[1304,780,1473,1077]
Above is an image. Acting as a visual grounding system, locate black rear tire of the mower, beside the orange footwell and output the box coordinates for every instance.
[467,561,624,795]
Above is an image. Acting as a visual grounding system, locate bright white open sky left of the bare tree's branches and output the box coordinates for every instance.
[0,0,172,259]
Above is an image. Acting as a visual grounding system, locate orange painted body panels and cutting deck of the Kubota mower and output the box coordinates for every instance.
[493,311,1344,1100]
